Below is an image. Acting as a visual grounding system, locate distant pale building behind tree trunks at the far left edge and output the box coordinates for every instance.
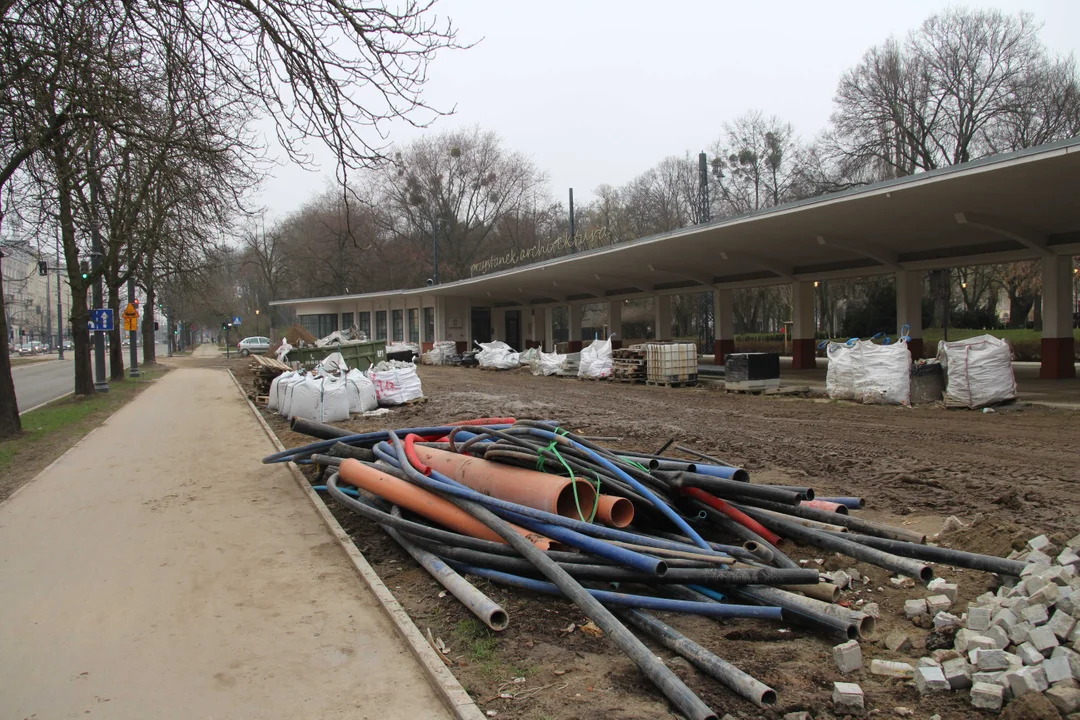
[0,244,71,345]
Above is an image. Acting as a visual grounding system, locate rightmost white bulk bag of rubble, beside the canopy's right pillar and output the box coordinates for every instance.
[937,335,1016,408]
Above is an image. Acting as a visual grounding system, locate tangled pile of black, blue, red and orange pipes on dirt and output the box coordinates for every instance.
[264,418,1027,720]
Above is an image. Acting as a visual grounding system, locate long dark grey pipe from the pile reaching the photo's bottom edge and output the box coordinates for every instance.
[390,432,716,720]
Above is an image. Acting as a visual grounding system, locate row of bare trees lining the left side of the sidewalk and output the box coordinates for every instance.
[0,0,457,437]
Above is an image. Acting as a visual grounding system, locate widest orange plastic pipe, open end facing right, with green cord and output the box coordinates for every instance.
[414,445,596,519]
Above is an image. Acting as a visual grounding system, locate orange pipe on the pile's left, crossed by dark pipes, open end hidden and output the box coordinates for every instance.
[338,458,553,551]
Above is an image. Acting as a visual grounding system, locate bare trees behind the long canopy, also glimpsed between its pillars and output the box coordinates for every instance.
[206,9,1080,345]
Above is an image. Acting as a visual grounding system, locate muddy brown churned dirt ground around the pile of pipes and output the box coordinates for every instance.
[232,362,1080,720]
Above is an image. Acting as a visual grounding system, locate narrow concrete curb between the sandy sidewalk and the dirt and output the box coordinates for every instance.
[229,370,486,720]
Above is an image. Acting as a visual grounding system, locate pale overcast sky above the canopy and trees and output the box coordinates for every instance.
[256,0,1080,218]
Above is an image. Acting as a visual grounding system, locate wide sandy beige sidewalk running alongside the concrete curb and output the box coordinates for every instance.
[0,369,449,720]
